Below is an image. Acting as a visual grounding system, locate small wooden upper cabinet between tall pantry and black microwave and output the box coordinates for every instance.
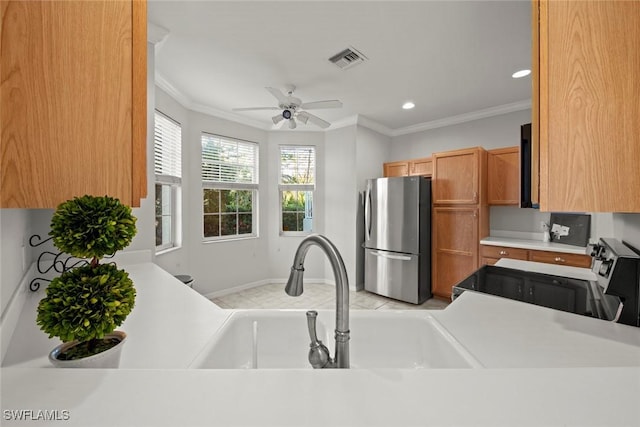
[487,147,520,206]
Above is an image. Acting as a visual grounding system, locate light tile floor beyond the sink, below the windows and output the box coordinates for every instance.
[211,283,449,310]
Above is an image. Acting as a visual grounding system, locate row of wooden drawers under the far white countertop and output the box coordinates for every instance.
[480,245,591,268]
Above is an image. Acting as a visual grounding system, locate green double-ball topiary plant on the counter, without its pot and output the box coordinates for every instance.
[36,196,136,359]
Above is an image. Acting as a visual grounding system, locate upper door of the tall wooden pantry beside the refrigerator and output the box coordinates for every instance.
[432,147,487,205]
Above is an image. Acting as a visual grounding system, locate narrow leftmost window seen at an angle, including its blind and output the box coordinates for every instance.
[153,111,182,251]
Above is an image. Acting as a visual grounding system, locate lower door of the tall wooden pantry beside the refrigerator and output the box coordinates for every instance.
[432,207,479,298]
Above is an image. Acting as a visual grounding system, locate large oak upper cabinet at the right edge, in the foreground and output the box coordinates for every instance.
[532,0,640,212]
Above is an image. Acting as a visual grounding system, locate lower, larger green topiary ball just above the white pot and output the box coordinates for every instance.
[37,264,136,342]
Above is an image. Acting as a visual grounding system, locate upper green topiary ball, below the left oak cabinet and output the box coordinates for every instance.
[49,196,136,259]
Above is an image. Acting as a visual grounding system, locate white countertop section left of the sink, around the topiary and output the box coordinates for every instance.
[2,262,229,369]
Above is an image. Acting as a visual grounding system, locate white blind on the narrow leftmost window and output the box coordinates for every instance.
[153,111,182,184]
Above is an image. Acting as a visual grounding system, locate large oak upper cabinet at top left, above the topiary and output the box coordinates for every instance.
[0,0,147,208]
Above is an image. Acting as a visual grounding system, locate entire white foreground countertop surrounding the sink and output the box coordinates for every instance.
[1,264,640,427]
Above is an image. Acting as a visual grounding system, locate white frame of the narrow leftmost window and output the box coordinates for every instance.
[154,108,182,254]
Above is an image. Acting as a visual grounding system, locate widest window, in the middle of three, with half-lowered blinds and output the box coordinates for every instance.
[202,133,258,240]
